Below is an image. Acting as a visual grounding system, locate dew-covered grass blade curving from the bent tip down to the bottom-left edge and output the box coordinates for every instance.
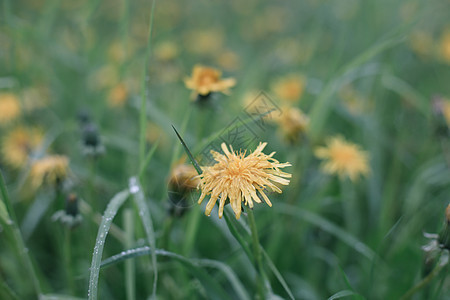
[88,190,130,300]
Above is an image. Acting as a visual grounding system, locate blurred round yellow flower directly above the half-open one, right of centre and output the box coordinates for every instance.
[272,74,305,102]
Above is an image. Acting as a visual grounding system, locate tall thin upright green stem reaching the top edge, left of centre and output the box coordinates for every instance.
[139,0,156,165]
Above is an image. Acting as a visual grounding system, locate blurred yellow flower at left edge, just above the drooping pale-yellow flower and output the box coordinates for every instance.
[1,127,43,168]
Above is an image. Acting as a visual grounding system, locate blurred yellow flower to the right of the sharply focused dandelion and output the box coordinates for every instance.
[314,136,370,181]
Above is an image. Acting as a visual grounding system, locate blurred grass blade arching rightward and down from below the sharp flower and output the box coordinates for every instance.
[275,203,376,260]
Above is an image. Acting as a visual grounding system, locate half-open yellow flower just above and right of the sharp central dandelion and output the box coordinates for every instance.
[274,106,309,142]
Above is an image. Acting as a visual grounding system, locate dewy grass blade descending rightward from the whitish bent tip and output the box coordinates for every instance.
[130,177,158,298]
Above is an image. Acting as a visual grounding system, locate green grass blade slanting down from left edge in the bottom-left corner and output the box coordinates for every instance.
[0,170,42,298]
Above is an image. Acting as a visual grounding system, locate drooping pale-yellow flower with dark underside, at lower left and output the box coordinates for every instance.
[30,155,69,188]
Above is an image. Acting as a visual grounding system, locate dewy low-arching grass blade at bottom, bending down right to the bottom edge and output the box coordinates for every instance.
[101,246,230,299]
